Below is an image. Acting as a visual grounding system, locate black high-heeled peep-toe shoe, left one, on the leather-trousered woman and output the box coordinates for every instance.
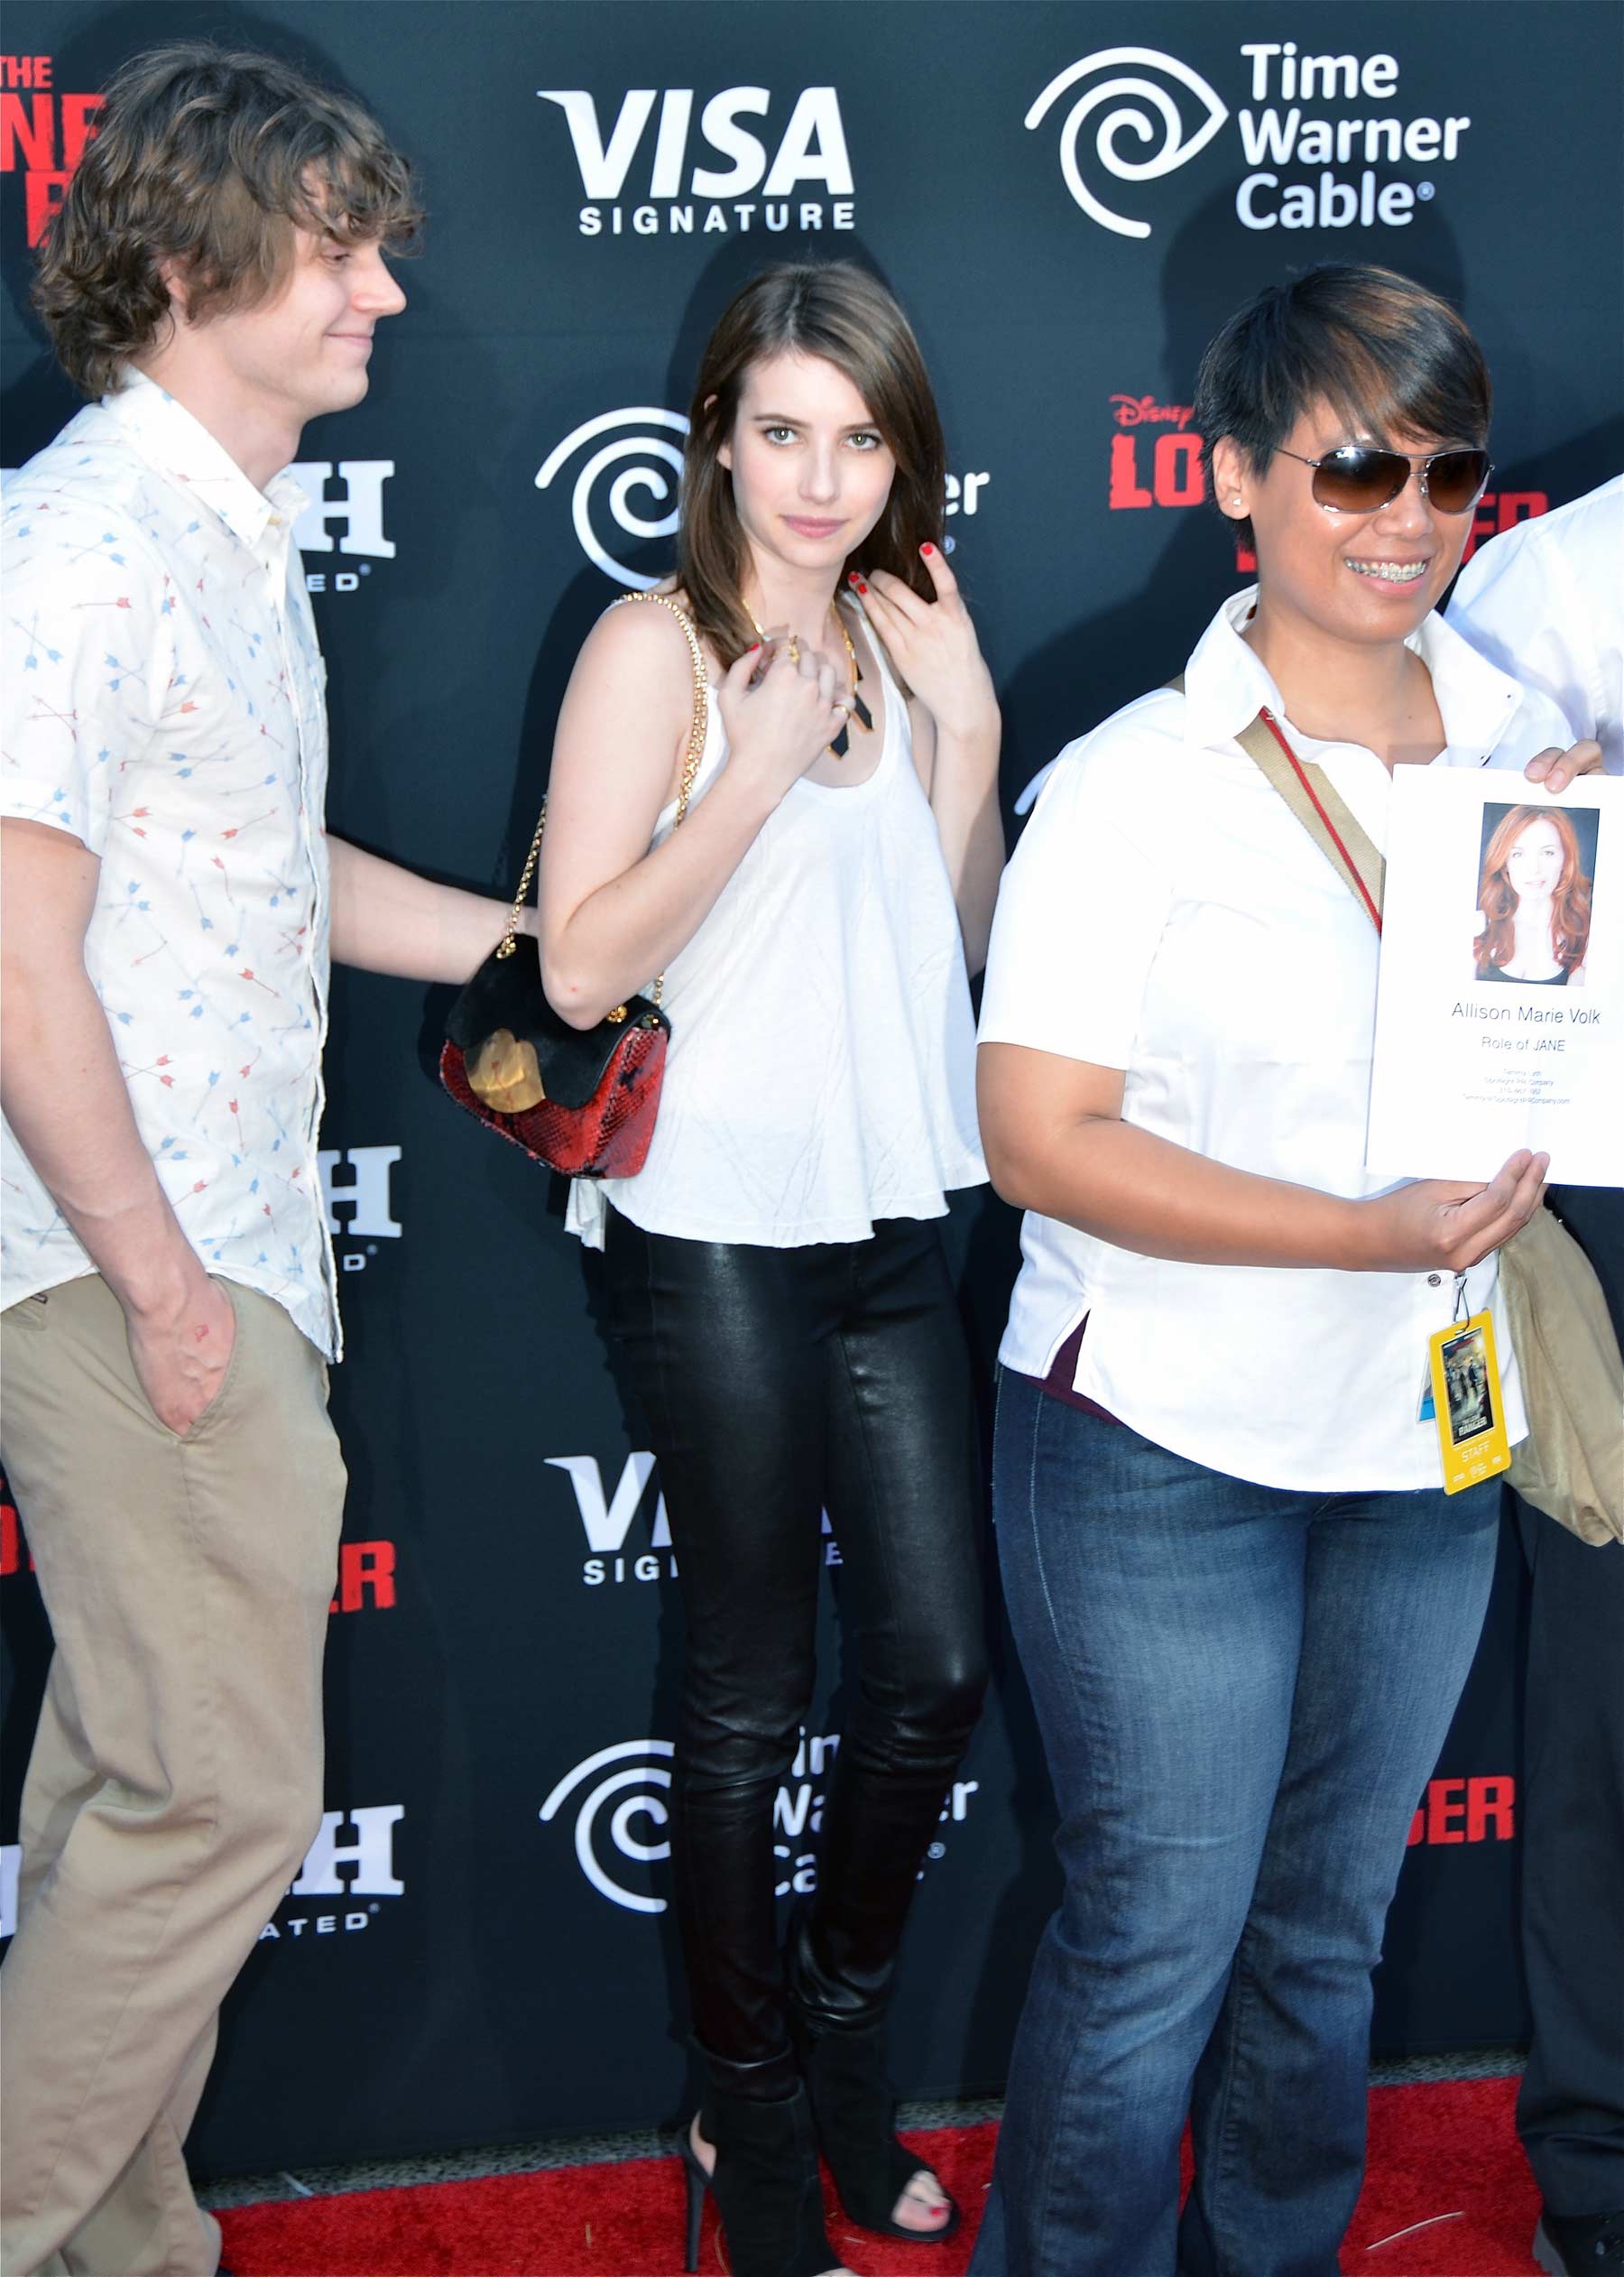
[681,2088,841,2277]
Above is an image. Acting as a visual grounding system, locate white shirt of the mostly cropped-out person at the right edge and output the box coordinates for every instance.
[1449,474,1624,774]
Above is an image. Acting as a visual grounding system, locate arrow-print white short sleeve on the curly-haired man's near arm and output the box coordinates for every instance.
[0,499,171,856]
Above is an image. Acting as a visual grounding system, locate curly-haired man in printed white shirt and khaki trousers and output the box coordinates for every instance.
[0,45,519,2277]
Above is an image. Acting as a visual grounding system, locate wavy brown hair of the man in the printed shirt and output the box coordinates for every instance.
[34,41,424,396]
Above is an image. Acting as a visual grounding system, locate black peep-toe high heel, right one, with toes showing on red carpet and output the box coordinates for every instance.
[790,1993,961,2245]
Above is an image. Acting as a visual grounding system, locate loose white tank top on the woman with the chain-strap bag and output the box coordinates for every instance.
[565,610,986,1250]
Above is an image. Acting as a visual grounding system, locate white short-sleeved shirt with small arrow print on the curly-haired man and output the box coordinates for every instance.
[0,374,339,1357]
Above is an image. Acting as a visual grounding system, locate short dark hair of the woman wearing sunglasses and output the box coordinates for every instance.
[1194,262,1492,541]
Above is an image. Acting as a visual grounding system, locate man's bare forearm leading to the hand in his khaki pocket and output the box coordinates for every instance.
[0,966,208,1319]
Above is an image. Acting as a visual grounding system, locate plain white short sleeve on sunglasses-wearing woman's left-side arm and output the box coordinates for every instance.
[980,719,1173,1068]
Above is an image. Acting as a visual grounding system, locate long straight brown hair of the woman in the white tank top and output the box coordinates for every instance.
[677,262,947,665]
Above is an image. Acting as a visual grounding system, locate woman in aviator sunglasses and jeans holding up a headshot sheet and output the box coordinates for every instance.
[973,266,1599,2277]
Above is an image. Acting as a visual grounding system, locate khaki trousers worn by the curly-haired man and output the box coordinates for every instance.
[0,1280,344,2277]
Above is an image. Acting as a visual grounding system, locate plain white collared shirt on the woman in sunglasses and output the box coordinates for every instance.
[980,592,1567,1492]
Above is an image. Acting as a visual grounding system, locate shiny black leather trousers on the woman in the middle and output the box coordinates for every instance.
[604,1209,986,2095]
